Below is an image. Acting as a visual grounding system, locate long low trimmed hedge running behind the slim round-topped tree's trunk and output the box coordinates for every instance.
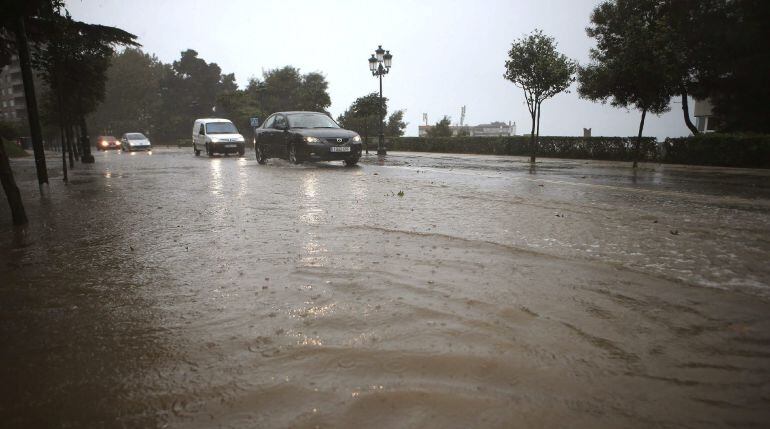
[386,136,659,161]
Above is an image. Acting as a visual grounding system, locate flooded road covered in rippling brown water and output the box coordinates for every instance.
[0,150,770,428]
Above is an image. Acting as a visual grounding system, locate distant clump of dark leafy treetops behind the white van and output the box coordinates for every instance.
[91,54,331,141]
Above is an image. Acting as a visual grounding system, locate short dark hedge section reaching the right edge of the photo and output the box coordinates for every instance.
[660,133,770,168]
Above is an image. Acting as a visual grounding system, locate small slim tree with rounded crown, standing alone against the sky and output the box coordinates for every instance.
[503,30,577,162]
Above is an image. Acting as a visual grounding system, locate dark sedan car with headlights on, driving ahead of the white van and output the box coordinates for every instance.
[254,112,361,166]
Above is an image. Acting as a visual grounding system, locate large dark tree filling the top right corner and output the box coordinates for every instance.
[651,0,770,134]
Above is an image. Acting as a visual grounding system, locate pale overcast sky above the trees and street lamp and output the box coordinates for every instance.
[67,0,692,138]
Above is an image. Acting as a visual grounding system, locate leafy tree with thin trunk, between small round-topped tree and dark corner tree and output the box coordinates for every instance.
[578,0,676,168]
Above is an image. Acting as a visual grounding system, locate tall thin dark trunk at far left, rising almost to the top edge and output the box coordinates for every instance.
[15,17,48,193]
